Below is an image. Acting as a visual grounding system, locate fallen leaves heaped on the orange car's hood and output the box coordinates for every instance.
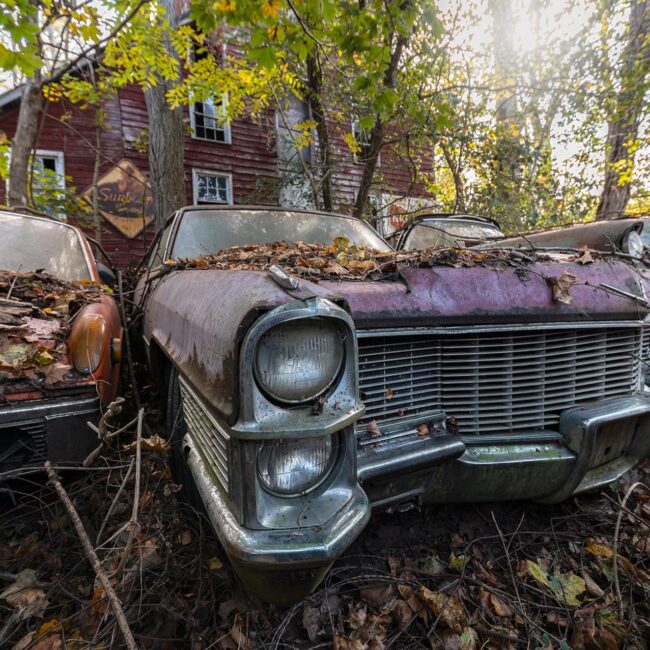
[0,270,99,393]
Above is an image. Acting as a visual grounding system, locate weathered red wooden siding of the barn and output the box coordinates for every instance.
[0,80,431,267]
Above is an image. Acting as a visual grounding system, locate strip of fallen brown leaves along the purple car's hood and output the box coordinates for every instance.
[168,237,550,281]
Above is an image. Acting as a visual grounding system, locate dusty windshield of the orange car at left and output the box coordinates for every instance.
[0,212,92,280]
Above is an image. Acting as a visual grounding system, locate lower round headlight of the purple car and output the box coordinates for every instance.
[257,436,336,497]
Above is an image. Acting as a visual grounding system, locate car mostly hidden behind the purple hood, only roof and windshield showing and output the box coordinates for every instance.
[389,214,505,250]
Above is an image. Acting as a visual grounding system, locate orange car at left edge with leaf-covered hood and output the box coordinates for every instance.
[0,211,122,468]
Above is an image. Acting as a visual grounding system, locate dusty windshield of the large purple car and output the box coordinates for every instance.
[169,209,391,259]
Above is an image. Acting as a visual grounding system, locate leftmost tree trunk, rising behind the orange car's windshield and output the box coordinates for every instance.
[8,72,43,207]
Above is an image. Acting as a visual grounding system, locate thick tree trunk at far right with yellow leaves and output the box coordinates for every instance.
[596,0,650,220]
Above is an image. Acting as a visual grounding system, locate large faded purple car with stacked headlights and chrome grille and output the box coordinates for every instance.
[137,206,650,602]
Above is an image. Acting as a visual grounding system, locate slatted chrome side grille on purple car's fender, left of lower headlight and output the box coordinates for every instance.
[180,379,230,491]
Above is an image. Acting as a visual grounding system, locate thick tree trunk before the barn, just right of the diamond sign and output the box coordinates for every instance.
[144,0,186,230]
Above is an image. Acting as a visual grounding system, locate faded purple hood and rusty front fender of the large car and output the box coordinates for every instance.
[139,261,648,424]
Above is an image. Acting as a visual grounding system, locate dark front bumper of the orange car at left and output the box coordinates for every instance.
[0,390,99,472]
